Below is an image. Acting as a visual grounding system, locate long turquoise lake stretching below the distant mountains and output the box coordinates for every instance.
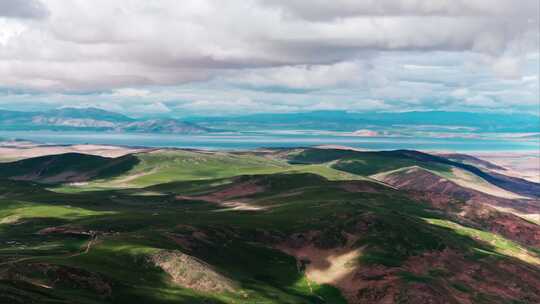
[0,131,540,152]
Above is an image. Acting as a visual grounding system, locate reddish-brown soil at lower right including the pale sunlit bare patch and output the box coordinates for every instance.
[275,226,540,304]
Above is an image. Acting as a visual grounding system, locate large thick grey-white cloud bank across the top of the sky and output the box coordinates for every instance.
[0,0,538,91]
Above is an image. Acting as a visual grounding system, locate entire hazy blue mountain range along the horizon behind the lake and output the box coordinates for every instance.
[0,108,540,137]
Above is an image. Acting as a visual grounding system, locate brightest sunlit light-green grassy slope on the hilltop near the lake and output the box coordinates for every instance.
[51,150,366,192]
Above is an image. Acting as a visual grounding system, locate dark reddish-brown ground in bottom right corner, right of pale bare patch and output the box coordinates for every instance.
[332,250,540,304]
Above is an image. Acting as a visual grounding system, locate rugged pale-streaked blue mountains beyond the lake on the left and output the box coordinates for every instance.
[0,108,210,134]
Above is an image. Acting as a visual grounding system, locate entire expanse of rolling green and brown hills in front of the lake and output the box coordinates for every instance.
[0,149,540,304]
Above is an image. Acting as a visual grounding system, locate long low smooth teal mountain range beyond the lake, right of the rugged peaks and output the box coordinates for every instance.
[189,111,540,132]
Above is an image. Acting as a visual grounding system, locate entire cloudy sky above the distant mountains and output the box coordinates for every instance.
[0,0,540,117]
